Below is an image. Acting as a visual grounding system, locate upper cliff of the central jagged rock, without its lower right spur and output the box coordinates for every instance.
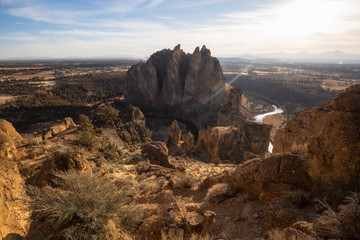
[127,45,230,106]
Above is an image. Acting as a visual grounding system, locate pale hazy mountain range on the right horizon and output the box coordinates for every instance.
[239,51,360,63]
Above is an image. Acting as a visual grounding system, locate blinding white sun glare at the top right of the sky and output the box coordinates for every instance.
[266,0,344,36]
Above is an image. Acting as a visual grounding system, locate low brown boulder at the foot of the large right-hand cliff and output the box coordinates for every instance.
[220,153,315,201]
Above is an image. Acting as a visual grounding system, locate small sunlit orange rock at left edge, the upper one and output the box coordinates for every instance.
[0,119,24,159]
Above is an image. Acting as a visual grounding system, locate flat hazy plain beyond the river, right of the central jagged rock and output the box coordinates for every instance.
[222,60,360,114]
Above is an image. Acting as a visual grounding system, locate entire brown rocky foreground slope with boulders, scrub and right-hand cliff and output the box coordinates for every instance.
[0,85,360,239]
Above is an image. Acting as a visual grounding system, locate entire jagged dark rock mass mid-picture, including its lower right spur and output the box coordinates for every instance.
[126,45,246,126]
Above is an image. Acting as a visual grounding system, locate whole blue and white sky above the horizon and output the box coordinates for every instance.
[0,0,360,59]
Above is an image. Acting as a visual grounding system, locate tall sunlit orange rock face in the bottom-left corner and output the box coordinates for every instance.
[0,158,30,239]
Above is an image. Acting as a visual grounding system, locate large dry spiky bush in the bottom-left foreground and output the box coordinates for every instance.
[27,171,131,240]
